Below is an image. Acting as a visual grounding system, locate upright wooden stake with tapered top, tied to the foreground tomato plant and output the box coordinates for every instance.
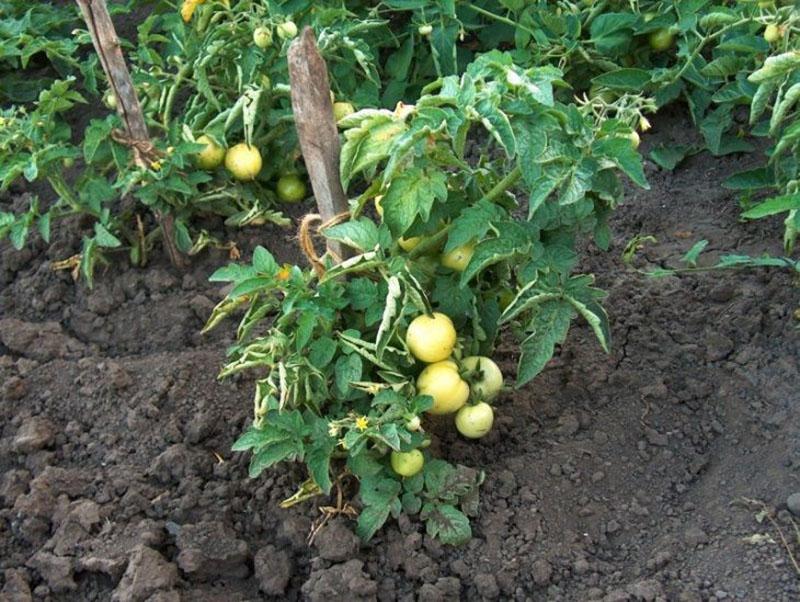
[288,27,349,258]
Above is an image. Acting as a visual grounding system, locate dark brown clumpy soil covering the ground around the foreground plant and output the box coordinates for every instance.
[0,109,800,602]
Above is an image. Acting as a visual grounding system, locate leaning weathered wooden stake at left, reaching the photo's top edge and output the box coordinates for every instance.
[76,0,185,267]
